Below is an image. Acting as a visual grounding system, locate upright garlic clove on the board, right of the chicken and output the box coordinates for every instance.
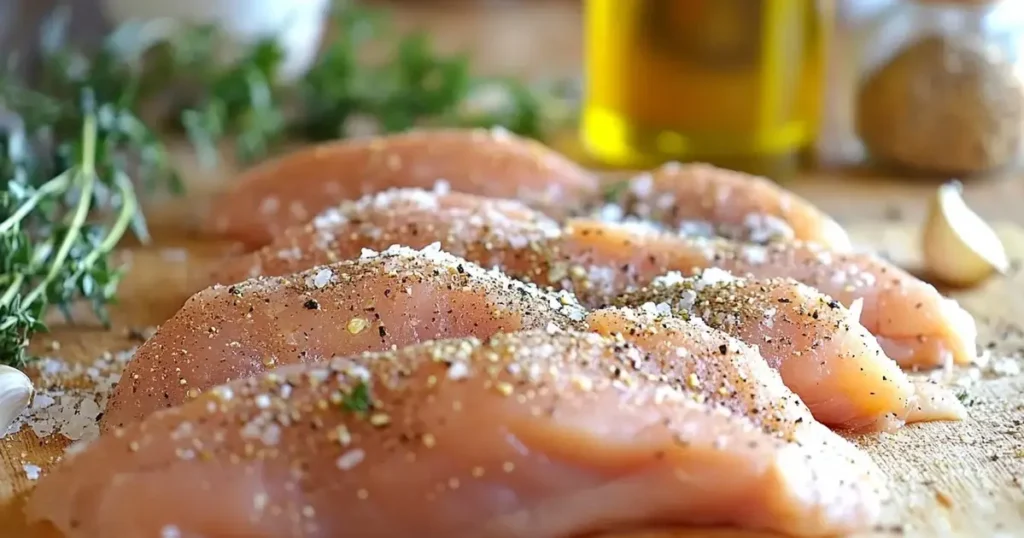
[923,181,1010,287]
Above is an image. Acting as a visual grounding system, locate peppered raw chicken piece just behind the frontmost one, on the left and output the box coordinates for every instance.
[101,245,585,429]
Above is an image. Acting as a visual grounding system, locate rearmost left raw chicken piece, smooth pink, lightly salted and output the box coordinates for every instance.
[206,129,599,248]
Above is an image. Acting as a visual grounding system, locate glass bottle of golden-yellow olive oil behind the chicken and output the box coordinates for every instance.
[581,0,834,176]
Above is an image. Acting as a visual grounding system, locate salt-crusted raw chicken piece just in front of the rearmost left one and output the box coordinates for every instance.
[207,189,561,287]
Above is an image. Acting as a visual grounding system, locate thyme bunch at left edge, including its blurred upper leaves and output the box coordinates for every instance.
[0,7,180,365]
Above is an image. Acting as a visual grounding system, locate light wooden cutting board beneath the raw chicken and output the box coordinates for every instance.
[0,174,1024,538]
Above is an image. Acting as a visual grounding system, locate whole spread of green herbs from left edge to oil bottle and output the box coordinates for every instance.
[0,2,573,365]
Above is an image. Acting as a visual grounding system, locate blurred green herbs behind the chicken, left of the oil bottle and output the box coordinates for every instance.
[172,2,561,162]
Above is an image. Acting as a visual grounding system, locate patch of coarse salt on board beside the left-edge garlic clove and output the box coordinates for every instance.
[0,347,135,446]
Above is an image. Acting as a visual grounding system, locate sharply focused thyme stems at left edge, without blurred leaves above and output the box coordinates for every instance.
[0,105,145,365]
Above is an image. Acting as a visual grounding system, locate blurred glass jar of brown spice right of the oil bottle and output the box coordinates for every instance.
[837,0,1024,177]
